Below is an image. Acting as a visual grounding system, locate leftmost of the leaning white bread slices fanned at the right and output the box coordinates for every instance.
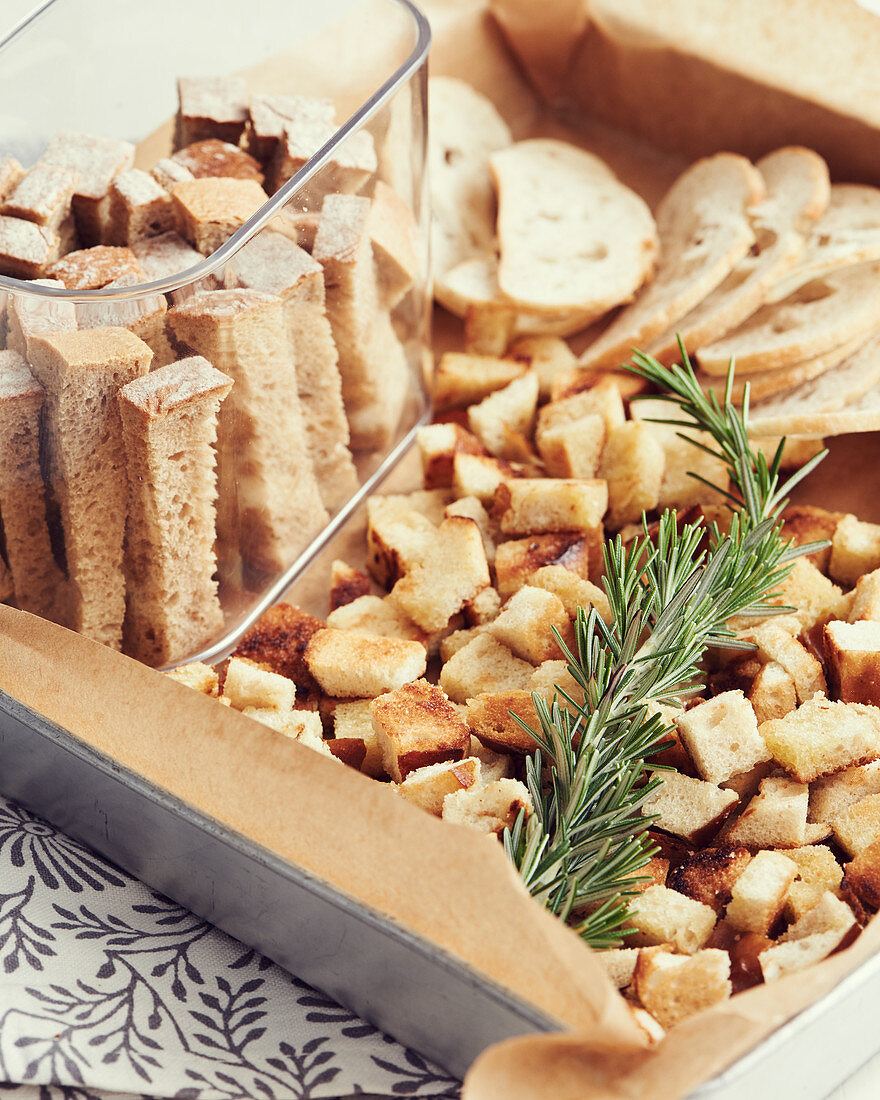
[581,153,765,366]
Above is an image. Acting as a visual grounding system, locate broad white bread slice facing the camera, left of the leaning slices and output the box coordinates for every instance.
[490,138,658,317]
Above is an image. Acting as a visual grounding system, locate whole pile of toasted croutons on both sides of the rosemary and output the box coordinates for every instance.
[172,338,880,1033]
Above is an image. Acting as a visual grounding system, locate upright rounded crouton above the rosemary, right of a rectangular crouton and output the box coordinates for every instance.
[598,420,666,530]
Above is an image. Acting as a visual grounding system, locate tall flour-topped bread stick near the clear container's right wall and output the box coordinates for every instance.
[312,195,409,450]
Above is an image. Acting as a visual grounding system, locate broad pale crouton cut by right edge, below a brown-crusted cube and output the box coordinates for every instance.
[761,694,880,783]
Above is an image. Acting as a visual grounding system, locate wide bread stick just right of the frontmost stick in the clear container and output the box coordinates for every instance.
[168,289,328,574]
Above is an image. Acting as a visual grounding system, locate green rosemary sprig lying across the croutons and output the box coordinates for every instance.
[504,345,825,947]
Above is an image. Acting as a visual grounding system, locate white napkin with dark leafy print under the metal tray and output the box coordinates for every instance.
[0,798,459,1100]
